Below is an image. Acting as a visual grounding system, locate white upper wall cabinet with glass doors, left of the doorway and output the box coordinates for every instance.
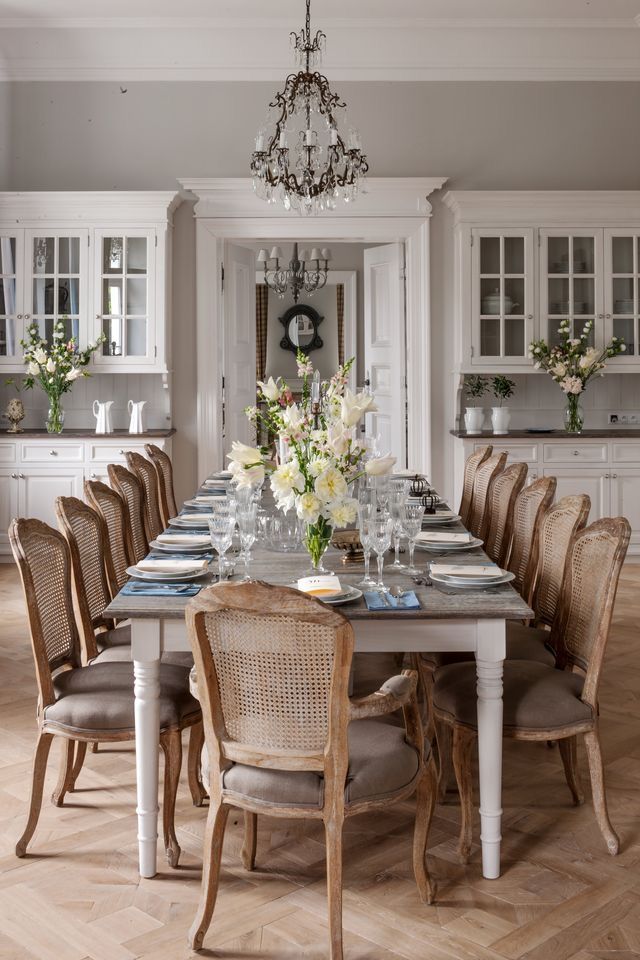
[0,191,177,373]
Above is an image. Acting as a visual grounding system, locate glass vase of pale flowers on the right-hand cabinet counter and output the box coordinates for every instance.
[529,320,627,433]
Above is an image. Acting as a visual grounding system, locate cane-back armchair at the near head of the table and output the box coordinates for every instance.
[186,581,435,960]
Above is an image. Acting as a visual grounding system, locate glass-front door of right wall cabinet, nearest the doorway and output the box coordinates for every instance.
[471,229,534,366]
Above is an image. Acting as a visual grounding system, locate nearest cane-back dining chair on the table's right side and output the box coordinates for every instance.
[433,517,631,861]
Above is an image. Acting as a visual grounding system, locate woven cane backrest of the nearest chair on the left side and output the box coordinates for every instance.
[9,518,81,710]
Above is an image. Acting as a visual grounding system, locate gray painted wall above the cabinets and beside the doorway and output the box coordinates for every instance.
[0,84,640,493]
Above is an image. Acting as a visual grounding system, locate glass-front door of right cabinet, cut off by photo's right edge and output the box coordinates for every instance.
[604,229,640,366]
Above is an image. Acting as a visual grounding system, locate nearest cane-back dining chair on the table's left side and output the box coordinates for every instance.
[9,519,202,866]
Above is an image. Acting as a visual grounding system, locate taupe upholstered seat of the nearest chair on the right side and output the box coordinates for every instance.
[433,660,593,732]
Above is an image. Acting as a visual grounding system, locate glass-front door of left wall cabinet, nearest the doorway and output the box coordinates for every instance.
[95,230,156,367]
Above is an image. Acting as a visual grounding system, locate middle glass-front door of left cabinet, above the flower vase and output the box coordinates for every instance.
[24,229,89,347]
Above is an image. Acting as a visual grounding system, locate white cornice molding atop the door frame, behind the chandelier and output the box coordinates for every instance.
[178,177,447,220]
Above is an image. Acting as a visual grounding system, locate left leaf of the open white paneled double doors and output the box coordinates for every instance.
[223,243,256,454]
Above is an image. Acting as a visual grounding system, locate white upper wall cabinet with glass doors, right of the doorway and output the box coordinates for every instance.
[444,191,640,373]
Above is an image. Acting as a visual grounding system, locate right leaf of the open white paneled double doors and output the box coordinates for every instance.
[364,243,407,467]
